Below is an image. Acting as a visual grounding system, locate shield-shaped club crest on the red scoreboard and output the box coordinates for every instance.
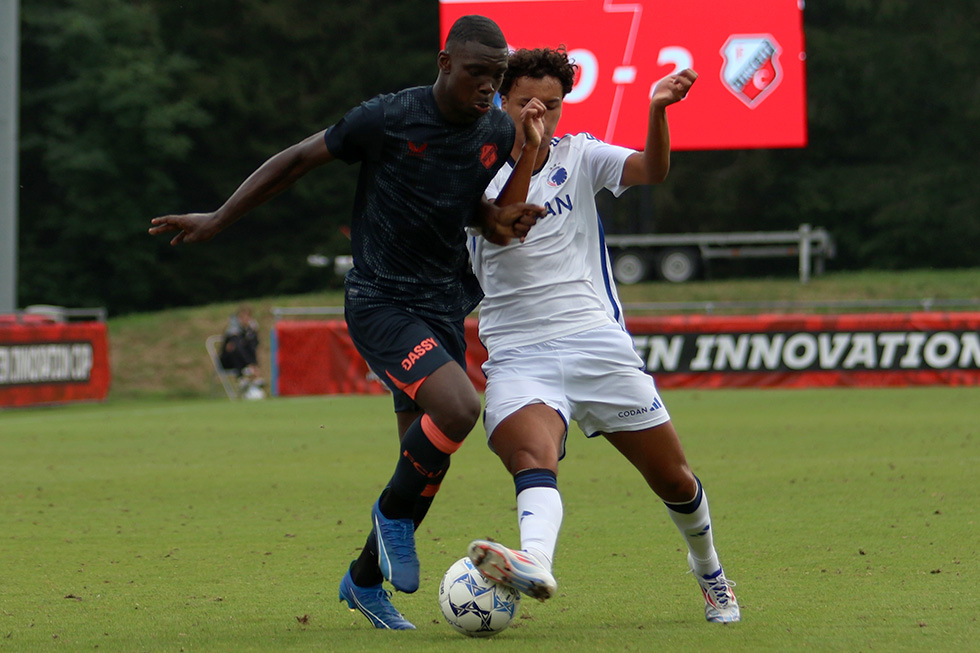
[721,34,783,109]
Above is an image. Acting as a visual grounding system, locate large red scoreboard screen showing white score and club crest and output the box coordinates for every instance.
[440,0,807,150]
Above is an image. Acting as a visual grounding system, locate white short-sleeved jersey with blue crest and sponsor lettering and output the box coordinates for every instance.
[467,134,634,352]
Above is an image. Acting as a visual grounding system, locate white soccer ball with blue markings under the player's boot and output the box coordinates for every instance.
[439,558,521,637]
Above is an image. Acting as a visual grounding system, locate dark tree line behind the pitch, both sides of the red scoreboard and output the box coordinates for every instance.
[19,0,980,314]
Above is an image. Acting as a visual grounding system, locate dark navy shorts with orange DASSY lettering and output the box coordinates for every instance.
[344,305,466,413]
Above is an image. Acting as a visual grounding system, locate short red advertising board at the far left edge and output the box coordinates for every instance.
[0,320,109,407]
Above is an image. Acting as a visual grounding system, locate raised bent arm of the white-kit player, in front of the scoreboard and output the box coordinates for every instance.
[622,68,698,186]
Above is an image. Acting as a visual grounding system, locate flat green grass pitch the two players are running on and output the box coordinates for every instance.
[0,388,980,652]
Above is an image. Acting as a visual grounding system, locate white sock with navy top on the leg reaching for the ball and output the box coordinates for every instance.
[514,469,564,572]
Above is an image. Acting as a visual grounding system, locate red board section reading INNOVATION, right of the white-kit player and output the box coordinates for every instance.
[626,312,980,388]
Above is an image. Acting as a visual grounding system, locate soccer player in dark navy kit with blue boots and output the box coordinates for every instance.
[149,16,544,630]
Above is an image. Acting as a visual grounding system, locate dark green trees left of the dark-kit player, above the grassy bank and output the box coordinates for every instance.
[19,0,438,314]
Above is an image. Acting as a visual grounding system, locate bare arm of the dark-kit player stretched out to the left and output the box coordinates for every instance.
[149,132,334,245]
